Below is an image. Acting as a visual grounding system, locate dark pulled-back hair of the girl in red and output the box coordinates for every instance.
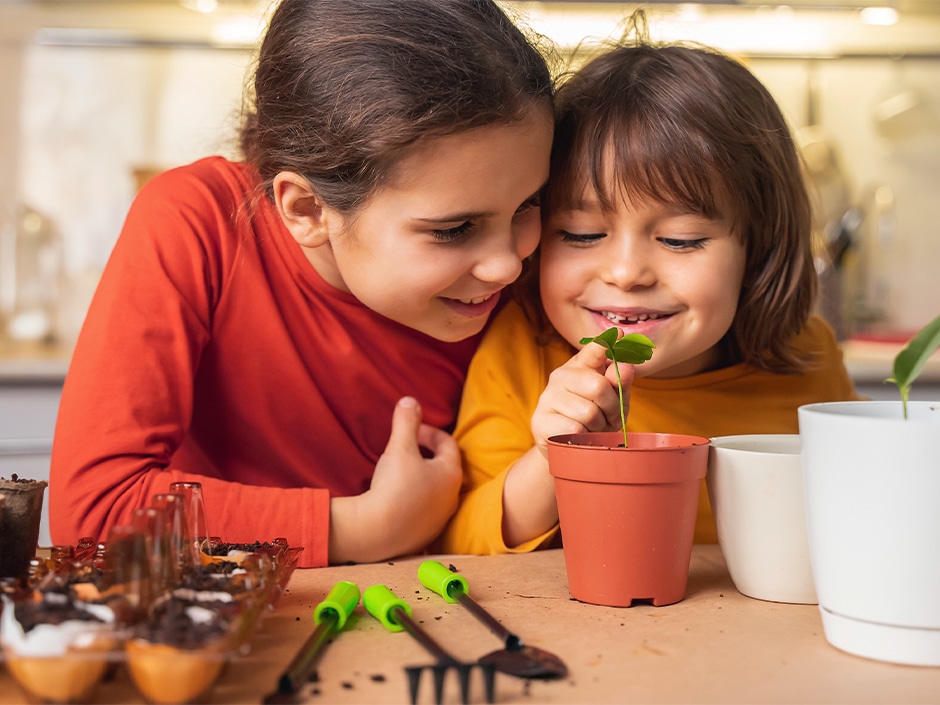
[240,0,554,212]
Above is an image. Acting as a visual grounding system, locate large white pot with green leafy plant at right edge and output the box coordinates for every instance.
[798,316,940,666]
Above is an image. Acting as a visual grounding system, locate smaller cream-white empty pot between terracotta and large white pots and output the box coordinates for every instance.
[707,433,816,604]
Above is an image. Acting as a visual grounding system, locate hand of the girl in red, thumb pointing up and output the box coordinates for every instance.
[330,397,462,564]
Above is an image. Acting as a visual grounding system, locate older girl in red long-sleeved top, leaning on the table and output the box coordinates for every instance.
[50,0,552,566]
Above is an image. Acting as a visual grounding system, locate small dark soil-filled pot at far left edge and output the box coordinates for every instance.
[0,476,48,578]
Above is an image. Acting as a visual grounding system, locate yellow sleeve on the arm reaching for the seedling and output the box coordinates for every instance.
[434,303,557,554]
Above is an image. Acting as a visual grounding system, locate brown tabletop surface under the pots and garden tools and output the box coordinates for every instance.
[0,546,940,705]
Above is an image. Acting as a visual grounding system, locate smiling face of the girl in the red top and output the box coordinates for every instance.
[301,106,552,341]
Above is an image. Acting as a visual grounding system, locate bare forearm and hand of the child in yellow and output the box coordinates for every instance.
[503,345,633,546]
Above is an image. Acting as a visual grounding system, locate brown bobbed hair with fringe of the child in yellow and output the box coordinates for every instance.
[529,42,816,372]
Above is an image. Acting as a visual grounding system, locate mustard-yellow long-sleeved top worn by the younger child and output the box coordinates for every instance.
[434,303,859,554]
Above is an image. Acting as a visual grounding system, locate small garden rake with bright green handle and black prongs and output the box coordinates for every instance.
[362,585,496,705]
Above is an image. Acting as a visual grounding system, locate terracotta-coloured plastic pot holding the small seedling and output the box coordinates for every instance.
[548,431,709,607]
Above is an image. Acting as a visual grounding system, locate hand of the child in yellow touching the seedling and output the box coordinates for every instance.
[532,345,634,458]
